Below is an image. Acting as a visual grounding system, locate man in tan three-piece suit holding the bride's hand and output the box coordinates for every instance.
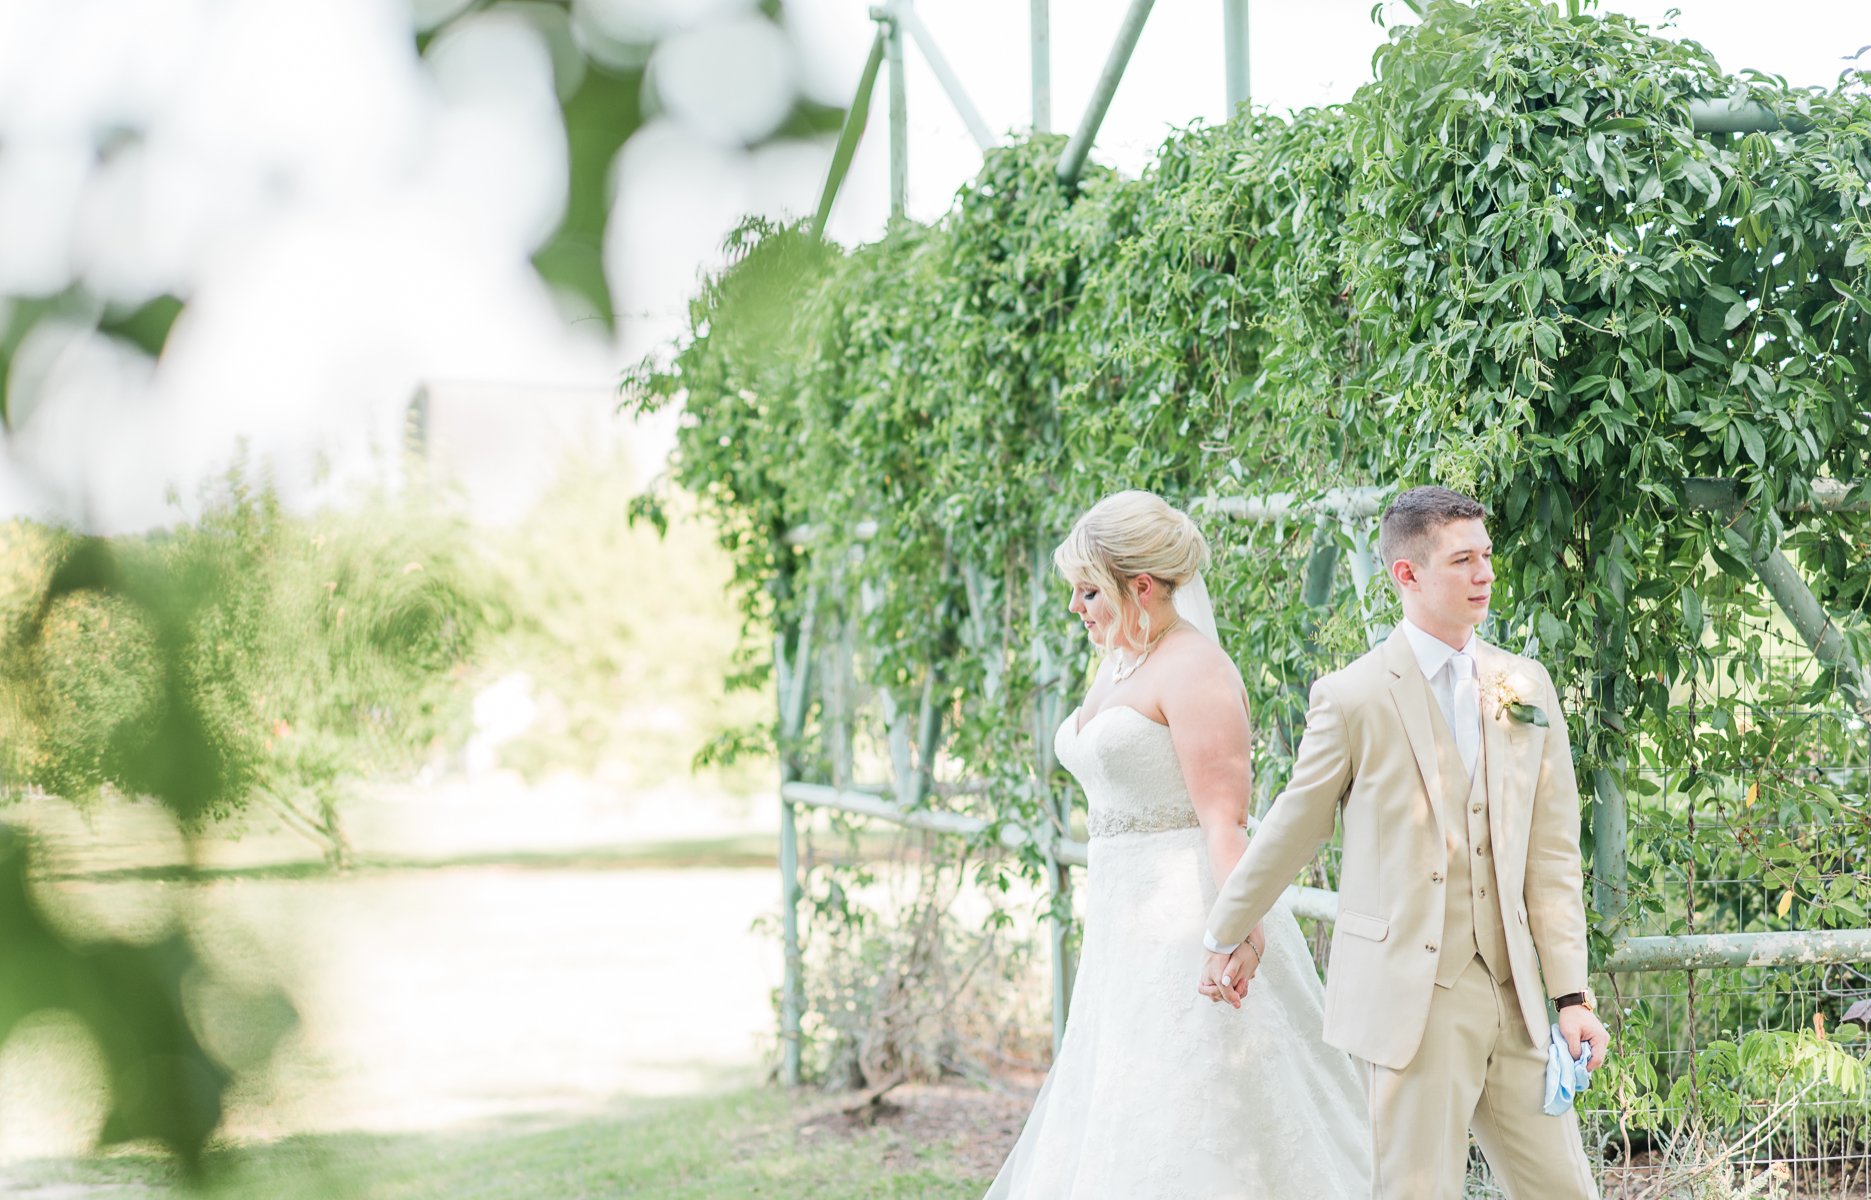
[1197,487,1609,1200]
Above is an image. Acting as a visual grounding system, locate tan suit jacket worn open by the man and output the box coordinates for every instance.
[1209,627,1587,1071]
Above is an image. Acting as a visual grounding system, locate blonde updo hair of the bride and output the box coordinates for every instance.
[1053,492,1211,650]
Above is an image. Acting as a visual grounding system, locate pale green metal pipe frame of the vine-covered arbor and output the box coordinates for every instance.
[775,0,1871,1086]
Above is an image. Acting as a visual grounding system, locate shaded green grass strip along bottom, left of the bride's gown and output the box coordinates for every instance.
[0,1088,1020,1200]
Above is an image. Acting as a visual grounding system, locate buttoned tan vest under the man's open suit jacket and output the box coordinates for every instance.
[1429,702,1514,987]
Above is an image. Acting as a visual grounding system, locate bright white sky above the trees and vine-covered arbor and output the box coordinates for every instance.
[0,0,1871,530]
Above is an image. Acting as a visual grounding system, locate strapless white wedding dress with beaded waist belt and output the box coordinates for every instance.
[988,706,1371,1200]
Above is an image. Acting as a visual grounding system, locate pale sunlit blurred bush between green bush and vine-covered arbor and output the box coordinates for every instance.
[477,459,771,794]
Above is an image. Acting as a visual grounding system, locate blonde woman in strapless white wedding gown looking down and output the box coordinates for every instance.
[988,492,1371,1200]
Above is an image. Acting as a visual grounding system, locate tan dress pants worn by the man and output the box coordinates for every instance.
[1360,957,1598,1200]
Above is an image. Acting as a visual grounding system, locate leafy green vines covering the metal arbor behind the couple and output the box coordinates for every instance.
[631,0,1871,1093]
